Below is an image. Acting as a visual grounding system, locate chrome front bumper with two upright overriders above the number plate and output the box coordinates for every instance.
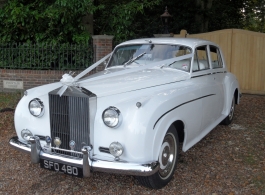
[9,136,159,177]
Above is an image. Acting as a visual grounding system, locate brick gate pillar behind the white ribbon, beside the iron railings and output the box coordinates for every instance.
[92,35,114,71]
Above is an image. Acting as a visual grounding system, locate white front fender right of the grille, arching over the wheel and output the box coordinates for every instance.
[93,82,202,163]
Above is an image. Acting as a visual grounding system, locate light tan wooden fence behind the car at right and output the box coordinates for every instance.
[174,29,265,95]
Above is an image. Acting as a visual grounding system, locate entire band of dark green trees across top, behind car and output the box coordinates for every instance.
[0,0,252,43]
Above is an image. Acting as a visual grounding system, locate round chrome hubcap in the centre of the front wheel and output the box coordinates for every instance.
[159,133,177,179]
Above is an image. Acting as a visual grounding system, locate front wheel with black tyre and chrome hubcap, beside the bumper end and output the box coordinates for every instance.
[137,126,179,189]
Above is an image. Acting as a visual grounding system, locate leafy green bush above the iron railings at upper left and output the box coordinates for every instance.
[0,0,102,44]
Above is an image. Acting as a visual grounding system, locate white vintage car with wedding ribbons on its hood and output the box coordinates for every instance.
[9,38,240,189]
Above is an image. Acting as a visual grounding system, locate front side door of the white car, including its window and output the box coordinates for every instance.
[192,45,223,134]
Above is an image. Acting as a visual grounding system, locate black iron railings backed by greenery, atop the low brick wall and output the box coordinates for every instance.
[0,43,93,70]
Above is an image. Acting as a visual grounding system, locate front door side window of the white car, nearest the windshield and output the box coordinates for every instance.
[192,45,209,72]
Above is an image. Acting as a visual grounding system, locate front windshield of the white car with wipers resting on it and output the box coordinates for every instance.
[108,44,192,68]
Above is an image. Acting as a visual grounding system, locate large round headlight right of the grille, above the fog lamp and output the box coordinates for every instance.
[102,107,121,128]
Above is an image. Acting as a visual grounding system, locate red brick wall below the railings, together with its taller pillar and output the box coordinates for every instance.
[0,35,113,92]
